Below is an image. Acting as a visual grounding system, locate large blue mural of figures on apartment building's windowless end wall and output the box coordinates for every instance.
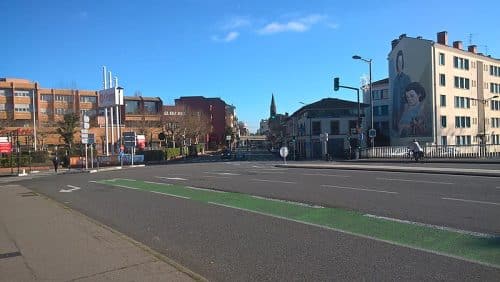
[389,38,434,144]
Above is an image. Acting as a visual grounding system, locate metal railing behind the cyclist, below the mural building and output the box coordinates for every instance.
[361,144,500,159]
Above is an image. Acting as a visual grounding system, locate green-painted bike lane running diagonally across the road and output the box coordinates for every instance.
[96,178,500,269]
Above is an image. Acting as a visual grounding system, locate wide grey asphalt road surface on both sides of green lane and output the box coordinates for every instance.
[16,162,500,281]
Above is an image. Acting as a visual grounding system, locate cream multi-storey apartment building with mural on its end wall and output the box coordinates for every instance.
[389,31,500,145]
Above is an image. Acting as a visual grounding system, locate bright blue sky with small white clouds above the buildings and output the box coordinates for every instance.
[0,0,500,132]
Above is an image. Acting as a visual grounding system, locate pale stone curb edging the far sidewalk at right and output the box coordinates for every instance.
[275,164,500,177]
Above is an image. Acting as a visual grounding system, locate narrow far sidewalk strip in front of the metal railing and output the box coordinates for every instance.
[276,162,500,177]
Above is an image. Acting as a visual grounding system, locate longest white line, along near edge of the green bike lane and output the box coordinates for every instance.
[208,202,500,269]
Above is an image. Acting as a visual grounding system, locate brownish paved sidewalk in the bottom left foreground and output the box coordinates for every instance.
[0,184,204,281]
